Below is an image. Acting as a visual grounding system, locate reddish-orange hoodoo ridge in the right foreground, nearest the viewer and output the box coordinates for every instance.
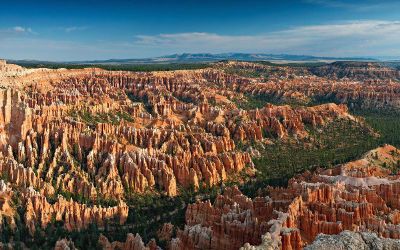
[171,145,400,249]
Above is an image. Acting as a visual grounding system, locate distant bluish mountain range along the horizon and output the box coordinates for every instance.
[8,53,378,64]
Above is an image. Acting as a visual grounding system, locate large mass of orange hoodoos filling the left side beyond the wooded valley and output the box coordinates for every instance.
[0,60,354,236]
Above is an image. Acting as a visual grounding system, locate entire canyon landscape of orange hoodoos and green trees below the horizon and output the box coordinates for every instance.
[0,61,400,250]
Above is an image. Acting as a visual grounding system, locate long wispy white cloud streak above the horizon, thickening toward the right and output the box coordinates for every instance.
[134,21,400,56]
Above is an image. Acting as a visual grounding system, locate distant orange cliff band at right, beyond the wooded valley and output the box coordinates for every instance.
[239,70,400,110]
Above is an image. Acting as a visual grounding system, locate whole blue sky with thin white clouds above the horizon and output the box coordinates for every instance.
[0,0,400,61]
